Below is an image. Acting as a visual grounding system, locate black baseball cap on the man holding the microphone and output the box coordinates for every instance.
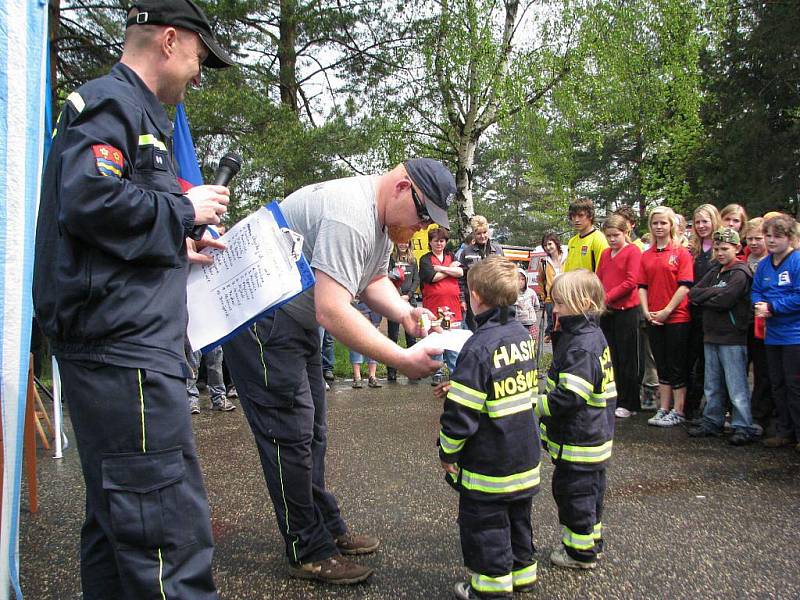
[126,0,235,69]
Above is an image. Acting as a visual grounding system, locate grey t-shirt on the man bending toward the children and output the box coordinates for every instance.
[281,176,392,329]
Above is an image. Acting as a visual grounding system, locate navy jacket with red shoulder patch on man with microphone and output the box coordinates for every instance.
[33,64,194,376]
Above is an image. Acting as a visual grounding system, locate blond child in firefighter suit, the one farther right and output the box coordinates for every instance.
[535,269,617,569]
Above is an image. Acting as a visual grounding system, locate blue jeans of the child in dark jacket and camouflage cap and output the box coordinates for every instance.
[703,344,756,435]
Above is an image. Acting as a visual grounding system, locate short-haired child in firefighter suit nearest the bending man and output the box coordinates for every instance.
[437,256,540,600]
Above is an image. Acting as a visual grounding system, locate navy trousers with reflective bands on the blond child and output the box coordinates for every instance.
[553,464,614,562]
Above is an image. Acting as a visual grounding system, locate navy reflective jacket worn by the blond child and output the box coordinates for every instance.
[536,315,617,471]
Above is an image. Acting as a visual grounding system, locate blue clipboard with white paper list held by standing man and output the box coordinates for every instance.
[187,202,314,351]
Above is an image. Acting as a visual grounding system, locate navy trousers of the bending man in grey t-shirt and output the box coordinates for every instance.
[224,310,347,564]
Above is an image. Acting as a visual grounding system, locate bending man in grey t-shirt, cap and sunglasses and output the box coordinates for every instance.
[225,158,456,584]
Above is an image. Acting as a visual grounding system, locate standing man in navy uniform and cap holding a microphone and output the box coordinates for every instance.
[34,0,232,600]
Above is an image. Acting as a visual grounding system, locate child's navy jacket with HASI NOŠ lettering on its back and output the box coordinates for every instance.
[439,307,541,500]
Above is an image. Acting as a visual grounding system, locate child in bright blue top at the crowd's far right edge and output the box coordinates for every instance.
[751,214,800,452]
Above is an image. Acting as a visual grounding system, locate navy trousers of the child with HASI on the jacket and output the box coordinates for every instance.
[458,494,536,598]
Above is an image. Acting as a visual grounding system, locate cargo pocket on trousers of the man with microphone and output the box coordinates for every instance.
[102,448,195,548]
